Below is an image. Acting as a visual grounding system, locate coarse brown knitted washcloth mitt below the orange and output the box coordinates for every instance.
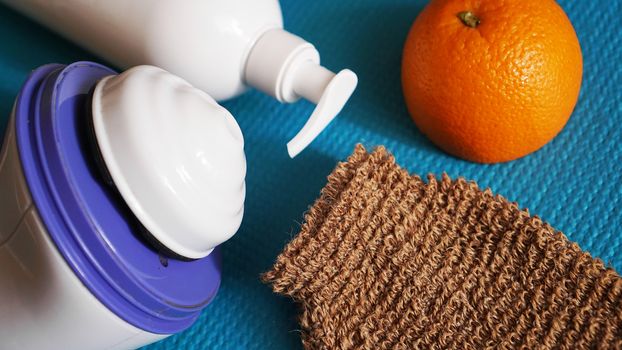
[264,146,622,349]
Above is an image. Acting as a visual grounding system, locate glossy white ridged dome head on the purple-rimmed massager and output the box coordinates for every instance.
[93,66,246,259]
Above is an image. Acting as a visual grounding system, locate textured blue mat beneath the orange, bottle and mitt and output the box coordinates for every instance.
[0,0,622,349]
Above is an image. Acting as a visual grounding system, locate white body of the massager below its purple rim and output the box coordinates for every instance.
[0,113,168,350]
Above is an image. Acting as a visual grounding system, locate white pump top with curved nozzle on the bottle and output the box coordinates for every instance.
[245,29,358,158]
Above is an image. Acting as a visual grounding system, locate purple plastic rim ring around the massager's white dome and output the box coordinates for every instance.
[15,62,221,334]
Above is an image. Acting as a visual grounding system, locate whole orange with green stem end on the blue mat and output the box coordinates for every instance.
[402,0,583,163]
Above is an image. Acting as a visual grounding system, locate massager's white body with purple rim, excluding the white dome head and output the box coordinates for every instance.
[0,62,234,350]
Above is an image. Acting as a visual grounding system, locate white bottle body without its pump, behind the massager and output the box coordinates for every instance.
[0,0,283,100]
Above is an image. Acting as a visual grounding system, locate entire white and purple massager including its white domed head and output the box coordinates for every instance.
[0,62,246,350]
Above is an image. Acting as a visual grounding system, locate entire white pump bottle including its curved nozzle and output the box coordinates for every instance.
[0,0,357,157]
